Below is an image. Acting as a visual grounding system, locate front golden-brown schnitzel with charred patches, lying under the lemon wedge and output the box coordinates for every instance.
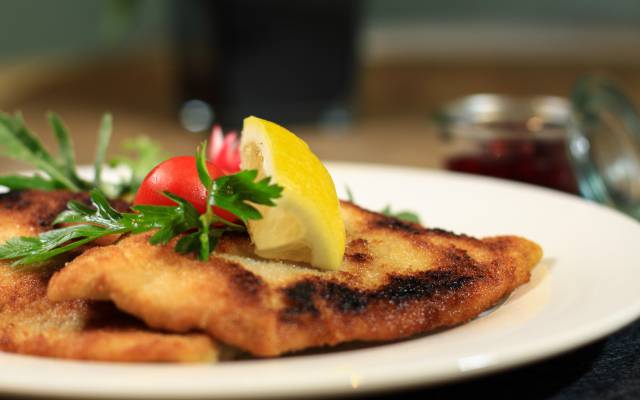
[48,202,542,356]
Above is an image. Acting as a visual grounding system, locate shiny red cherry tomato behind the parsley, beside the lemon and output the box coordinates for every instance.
[133,156,237,221]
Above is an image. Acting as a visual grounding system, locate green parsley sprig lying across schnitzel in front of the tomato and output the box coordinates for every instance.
[0,144,283,266]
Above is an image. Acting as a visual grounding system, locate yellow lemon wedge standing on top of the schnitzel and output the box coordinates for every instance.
[240,117,345,270]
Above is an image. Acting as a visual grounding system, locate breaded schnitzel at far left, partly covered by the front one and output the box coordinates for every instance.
[0,190,218,362]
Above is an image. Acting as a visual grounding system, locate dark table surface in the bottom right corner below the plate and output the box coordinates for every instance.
[374,321,640,400]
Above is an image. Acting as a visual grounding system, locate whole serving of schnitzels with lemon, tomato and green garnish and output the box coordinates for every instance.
[0,113,542,362]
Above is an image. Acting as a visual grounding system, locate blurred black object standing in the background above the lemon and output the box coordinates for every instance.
[175,0,360,128]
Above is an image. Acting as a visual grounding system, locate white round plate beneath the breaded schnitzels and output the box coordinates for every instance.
[0,163,640,399]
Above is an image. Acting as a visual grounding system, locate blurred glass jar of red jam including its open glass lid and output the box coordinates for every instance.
[436,76,640,219]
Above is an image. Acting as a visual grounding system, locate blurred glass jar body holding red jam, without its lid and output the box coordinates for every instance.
[441,95,578,194]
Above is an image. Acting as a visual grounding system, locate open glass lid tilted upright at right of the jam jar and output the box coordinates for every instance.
[568,76,640,219]
